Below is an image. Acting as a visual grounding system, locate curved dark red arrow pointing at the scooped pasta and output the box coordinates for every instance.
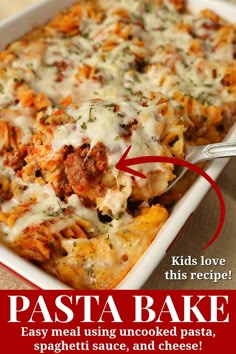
[116,146,225,249]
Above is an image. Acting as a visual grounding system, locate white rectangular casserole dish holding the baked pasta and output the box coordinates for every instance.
[0,0,236,289]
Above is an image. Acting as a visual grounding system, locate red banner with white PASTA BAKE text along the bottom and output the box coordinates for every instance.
[0,290,236,354]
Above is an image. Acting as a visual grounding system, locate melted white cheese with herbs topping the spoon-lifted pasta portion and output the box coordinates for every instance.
[51,98,165,173]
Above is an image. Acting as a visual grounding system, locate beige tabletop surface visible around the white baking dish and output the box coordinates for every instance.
[0,0,236,289]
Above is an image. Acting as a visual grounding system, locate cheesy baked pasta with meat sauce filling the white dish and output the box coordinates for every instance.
[0,0,236,289]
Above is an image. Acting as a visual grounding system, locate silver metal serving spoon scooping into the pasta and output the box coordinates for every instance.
[165,141,236,192]
